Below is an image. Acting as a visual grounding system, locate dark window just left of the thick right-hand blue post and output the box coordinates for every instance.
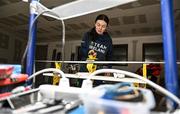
[143,43,163,62]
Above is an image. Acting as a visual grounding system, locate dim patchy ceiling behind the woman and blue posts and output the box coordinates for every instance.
[0,0,180,42]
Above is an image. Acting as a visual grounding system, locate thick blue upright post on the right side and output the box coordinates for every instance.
[161,0,179,107]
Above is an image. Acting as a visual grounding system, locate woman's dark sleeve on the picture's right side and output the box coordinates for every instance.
[106,39,113,68]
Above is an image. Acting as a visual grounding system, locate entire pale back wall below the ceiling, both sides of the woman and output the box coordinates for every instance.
[43,35,162,71]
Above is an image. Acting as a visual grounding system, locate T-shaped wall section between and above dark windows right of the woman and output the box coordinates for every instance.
[113,35,162,72]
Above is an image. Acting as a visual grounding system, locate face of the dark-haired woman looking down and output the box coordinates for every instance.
[95,20,107,35]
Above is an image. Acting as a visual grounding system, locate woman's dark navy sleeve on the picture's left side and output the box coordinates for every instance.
[80,33,89,61]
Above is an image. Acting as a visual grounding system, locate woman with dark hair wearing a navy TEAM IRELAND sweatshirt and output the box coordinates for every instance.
[80,14,112,72]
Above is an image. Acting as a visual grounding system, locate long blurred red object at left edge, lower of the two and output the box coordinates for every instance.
[0,74,28,86]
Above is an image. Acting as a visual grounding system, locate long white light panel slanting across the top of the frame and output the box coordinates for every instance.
[44,0,137,20]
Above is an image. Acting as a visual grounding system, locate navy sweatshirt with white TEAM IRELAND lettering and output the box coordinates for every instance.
[80,28,112,71]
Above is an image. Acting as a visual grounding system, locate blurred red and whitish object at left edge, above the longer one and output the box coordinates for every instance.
[0,65,14,79]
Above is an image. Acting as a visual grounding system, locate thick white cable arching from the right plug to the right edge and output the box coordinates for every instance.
[87,69,180,107]
